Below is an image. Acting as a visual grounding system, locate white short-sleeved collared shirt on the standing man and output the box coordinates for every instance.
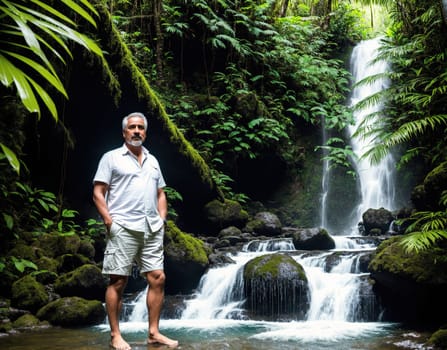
[93,144,166,232]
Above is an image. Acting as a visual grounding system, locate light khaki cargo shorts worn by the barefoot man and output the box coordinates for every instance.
[102,223,164,276]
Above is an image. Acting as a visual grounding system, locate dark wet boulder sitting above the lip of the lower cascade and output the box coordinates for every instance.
[289,227,335,250]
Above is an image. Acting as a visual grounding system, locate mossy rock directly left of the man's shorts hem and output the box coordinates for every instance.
[54,264,107,300]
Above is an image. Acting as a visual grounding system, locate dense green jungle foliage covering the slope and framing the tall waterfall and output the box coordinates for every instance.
[0,0,447,278]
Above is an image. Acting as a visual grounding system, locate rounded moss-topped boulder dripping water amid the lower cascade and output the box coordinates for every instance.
[243,253,309,320]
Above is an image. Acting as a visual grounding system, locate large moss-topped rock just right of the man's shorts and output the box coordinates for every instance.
[164,221,211,294]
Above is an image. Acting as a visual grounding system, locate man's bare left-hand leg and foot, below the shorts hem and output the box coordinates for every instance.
[106,275,131,350]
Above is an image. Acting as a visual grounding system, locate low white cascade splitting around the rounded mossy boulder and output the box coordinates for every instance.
[175,239,377,321]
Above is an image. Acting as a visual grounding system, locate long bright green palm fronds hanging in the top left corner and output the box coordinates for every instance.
[0,0,102,120]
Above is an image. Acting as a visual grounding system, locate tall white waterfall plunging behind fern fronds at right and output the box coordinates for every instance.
[348,38,395,228]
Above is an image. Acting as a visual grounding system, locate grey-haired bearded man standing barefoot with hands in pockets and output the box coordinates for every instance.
[93,113,178,350]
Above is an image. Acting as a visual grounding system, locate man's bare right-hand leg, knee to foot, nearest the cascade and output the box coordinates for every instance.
[146,270,178,347]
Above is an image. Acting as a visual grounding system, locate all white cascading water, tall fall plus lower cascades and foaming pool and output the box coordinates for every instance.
[93,39,412,350]
